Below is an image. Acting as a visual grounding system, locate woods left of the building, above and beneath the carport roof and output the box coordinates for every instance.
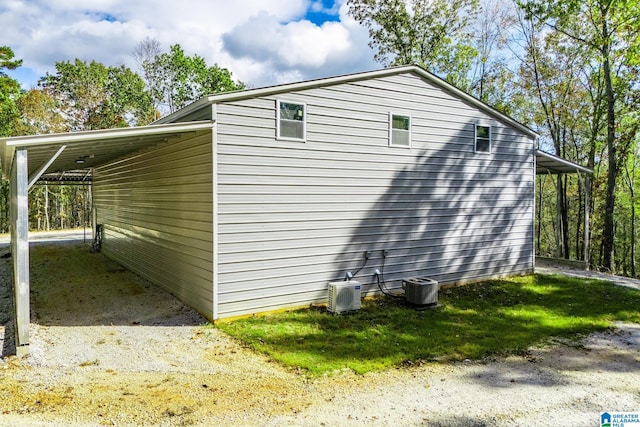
[0,39,244,241]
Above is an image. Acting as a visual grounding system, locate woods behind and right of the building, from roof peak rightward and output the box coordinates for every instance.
[347,0,640,276]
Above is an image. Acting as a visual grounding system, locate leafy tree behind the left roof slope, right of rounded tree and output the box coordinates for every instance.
[141,41,244,112]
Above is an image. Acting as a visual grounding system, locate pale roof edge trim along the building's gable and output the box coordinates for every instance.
[154,65,538,138]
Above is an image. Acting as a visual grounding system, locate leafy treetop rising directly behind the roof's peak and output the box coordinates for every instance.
[347,0,479,88]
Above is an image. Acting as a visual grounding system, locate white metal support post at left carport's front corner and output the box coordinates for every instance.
[11,149,30,356]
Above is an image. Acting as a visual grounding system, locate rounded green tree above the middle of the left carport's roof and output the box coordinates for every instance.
[40,59,154,130]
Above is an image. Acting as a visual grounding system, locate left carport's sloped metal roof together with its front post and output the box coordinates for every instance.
[0,121,212,355]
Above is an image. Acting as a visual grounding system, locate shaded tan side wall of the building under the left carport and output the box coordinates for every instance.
[94,131,213,319]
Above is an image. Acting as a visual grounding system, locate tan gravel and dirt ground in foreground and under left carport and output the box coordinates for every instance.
[0,236,640,426]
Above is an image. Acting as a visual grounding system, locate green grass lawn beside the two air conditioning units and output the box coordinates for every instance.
[217,275,640,376]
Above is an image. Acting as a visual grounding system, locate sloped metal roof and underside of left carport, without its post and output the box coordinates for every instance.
[0,121,212,181]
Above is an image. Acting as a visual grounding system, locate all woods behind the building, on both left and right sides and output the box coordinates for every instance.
[0,0,640,276]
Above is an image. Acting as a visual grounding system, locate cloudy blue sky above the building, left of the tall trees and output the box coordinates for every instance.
[0,0,379,88]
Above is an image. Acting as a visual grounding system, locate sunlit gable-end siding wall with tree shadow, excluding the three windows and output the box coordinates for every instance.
[216,74,534,317]
